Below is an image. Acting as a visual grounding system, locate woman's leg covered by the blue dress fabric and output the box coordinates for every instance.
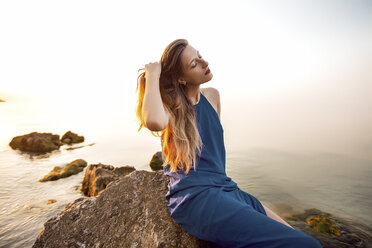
[175,188,322,248]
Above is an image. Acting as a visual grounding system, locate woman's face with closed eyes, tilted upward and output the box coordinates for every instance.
[179,45,213,84]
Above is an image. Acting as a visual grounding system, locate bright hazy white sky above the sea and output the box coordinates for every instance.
[0,0,372,159]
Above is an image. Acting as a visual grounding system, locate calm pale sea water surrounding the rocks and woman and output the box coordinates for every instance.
[0,102,372,247]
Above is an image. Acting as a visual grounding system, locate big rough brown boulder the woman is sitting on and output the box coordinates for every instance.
[33,171,209,248]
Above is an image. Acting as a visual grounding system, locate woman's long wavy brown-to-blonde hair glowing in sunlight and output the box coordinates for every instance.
[136,39,203,174]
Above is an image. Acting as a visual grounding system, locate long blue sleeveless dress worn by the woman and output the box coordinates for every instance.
[162,93,322,248]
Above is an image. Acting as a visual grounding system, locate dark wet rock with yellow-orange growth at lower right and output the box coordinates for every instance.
[286,209,372,248]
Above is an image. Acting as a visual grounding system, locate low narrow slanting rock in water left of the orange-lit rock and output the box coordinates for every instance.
[39,159,87,182]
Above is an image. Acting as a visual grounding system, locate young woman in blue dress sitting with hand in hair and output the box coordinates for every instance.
[136,39,321,248]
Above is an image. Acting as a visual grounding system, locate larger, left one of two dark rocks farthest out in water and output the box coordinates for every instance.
[9,132,62,153]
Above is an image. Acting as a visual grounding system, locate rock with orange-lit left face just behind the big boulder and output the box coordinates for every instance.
[80,163,136,196]
